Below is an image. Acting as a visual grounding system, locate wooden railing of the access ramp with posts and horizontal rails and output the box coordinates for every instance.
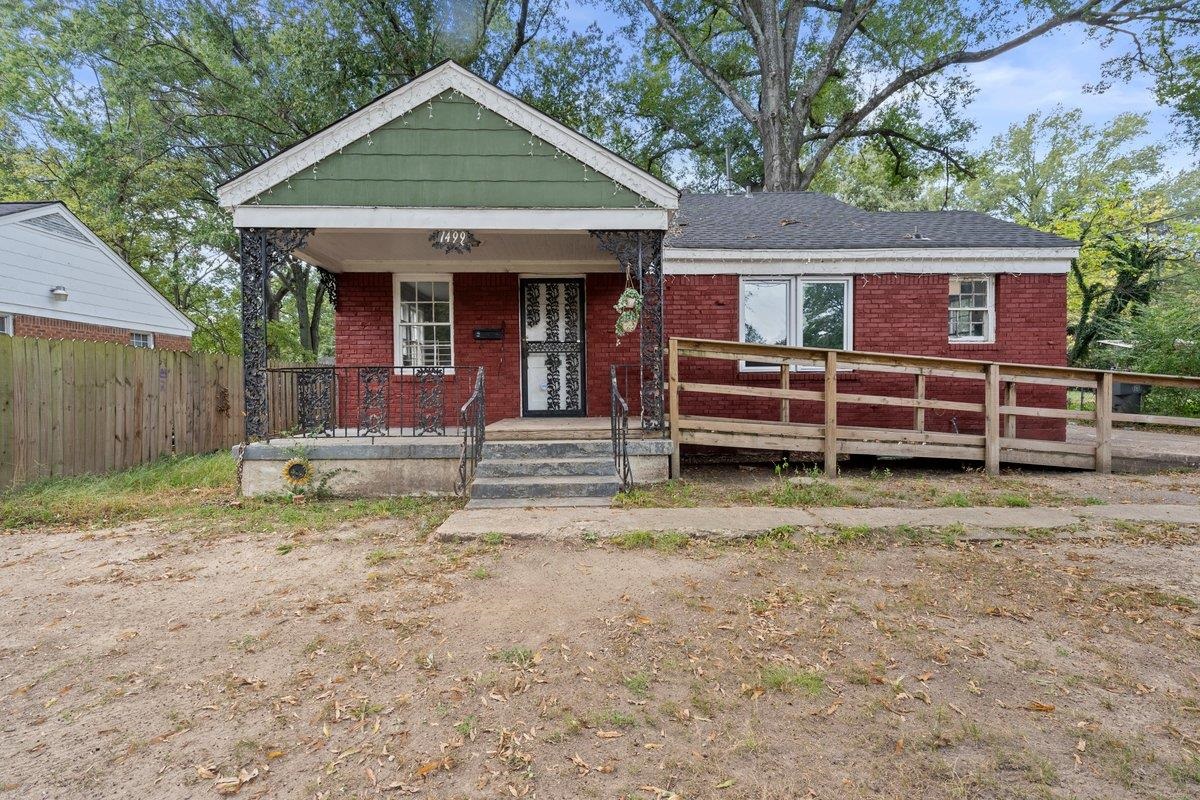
[667,338,1200,477]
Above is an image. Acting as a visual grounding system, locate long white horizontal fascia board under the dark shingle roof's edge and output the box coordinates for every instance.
[662,247,1079,275]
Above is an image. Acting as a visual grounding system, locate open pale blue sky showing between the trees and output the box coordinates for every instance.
[565,0,1198,172]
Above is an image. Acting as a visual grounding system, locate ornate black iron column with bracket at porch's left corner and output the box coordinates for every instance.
[239,228,312,441]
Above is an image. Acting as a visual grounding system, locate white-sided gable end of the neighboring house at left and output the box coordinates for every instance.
[0,200,196,336]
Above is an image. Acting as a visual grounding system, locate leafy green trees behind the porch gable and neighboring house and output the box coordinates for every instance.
[0,0,604,359]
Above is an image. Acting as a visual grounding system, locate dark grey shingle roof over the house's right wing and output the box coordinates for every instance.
[665,192,1079,249]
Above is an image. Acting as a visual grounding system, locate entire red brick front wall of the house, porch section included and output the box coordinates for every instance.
[334,272,1067,439]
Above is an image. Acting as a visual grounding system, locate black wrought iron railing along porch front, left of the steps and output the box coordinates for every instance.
[266,365,482,439]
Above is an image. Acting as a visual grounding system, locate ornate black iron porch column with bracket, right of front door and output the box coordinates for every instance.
[592,230,666,431]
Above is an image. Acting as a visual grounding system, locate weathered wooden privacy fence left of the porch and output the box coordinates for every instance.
[0,336,300,491]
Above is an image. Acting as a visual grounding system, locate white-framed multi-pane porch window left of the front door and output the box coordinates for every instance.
[392,273,454,367]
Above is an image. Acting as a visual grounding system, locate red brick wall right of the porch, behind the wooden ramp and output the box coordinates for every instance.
[667,275,1067,439]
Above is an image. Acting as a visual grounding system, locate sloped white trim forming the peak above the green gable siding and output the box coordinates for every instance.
[217,61,679,210]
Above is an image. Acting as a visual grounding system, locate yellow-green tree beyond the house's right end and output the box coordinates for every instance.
[958,109,1198,363]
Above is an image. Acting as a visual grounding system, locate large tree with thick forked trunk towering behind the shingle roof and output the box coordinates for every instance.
[610,0,1200,191]
